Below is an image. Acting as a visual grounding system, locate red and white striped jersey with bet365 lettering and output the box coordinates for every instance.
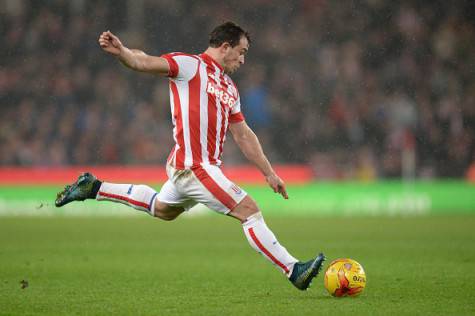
[161,53,244,170]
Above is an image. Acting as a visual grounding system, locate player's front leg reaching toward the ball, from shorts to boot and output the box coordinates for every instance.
[186,165,325,290]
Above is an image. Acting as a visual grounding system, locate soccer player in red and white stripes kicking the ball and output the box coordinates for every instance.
[55,22,325,290]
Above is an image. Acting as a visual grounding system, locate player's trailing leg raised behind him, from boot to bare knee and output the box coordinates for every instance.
[55,172,185,220]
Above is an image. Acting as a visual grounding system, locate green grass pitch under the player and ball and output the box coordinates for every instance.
[0,215,475,315]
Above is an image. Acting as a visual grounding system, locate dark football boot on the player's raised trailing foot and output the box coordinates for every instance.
[54,172,101,207]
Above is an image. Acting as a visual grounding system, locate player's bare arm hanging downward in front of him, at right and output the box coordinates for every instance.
[229,121,289,199]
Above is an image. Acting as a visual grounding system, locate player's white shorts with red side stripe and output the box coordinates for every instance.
[157,164,247,214]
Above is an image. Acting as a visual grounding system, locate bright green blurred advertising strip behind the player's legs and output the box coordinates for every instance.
[0,181,475,216]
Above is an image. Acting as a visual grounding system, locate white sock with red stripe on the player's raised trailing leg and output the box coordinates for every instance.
[96,182,157,216]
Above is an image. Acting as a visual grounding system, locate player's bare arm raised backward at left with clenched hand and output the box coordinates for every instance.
[99,31,170,76]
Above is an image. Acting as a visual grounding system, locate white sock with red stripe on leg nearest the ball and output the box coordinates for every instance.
[242,212,298,277]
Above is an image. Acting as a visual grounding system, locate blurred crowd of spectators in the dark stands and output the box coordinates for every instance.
[0,0,475,180]
